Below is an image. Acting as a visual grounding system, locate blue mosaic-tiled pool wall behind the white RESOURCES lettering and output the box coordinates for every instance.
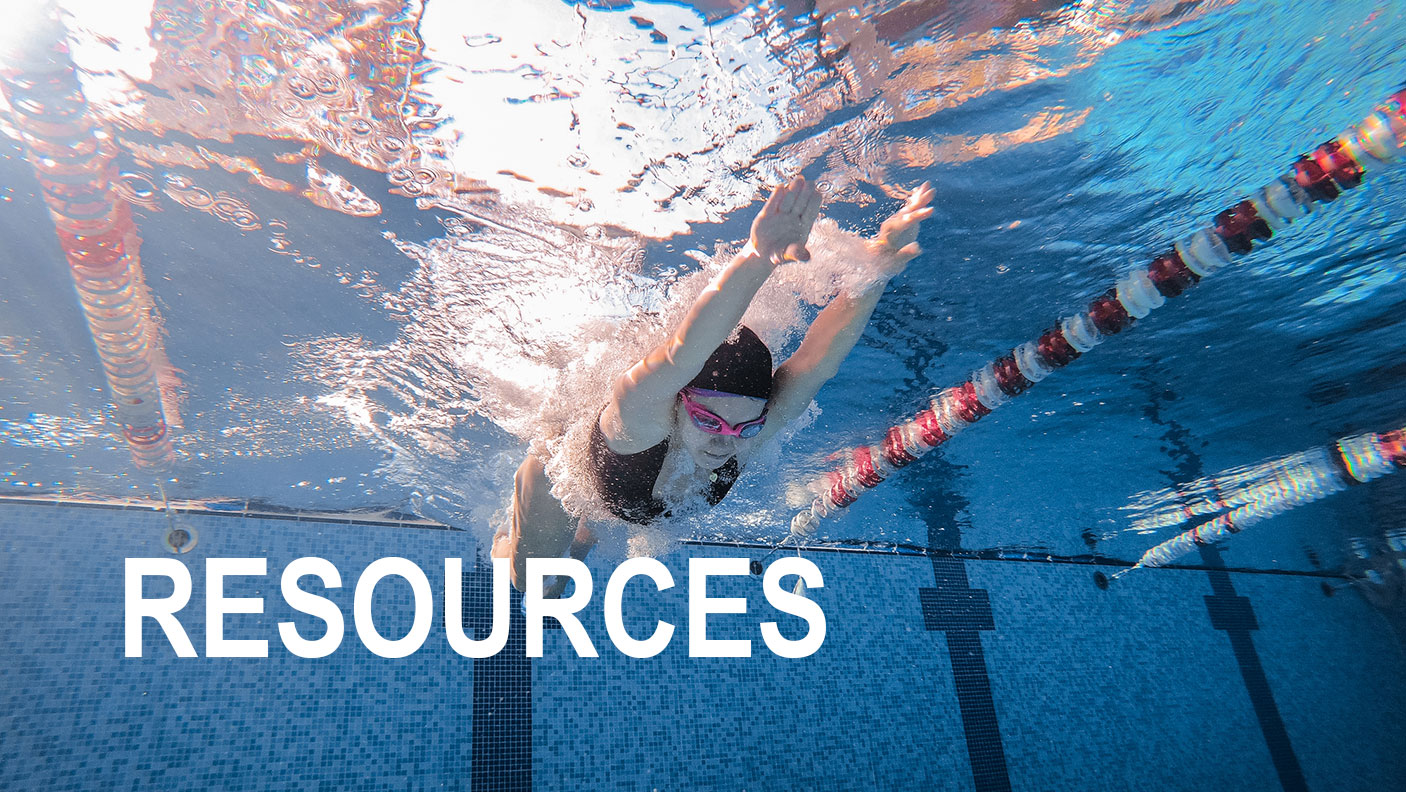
[0,504,1406,792]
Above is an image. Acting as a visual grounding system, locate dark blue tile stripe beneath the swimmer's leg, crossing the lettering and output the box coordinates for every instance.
[464,557,531,792]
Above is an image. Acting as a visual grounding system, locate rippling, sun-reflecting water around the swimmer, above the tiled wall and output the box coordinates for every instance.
[0,0,1406,563]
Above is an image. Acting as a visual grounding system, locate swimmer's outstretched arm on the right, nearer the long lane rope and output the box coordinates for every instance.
[762,184,934,440]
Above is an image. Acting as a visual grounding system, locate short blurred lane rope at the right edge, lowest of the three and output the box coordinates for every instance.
[1114,429,1406,578]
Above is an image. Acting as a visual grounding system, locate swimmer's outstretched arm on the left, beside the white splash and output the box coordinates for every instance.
[600,179,820,453]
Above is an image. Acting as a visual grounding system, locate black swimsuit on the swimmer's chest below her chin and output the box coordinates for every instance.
[591,418,741,525]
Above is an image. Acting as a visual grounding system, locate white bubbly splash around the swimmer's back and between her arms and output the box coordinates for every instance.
[298,189,868,547]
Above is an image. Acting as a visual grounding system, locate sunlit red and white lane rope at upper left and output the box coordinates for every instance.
[0,10,173,470]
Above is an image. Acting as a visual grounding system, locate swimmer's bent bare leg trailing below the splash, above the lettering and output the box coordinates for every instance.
[492,454,576,591]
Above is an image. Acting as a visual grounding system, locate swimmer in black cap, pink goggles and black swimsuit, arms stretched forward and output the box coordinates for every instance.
[492,179,934,596]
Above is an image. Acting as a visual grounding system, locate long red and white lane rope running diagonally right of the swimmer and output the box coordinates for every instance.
[792,83,1406,536]
